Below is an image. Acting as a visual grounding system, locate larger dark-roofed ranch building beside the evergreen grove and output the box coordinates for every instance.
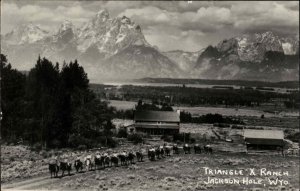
[133,110,180,135]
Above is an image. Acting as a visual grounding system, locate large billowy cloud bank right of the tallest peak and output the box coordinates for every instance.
[119,1,299,50]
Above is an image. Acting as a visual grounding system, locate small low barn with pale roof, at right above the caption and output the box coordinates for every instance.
[244,129,284,149]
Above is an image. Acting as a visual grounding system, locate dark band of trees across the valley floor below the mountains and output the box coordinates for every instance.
[101,85,300,108]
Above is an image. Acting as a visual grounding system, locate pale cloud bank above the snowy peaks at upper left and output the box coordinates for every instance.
[1,1,94,34]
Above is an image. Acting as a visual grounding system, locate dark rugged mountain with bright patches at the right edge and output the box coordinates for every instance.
[193,32,299,81]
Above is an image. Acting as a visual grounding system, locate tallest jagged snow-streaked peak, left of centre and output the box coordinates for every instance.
[78,9,149,55]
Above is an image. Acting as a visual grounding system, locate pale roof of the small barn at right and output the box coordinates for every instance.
[244,129,284,139]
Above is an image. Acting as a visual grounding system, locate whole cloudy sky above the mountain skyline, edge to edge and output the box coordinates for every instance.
[1,0,299,51]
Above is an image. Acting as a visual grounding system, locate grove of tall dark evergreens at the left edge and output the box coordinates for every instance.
[0,54,113,148]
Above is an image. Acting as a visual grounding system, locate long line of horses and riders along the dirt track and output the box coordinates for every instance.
[49,144,213,178]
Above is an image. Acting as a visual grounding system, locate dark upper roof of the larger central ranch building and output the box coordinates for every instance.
[134,111,180,122]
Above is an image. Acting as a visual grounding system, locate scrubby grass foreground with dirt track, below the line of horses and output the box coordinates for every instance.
[1,145,299,191]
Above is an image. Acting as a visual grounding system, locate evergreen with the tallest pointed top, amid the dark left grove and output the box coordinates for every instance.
[26,57,59,146]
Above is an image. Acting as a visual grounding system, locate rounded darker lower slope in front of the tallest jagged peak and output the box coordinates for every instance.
[104,45,184,79]
